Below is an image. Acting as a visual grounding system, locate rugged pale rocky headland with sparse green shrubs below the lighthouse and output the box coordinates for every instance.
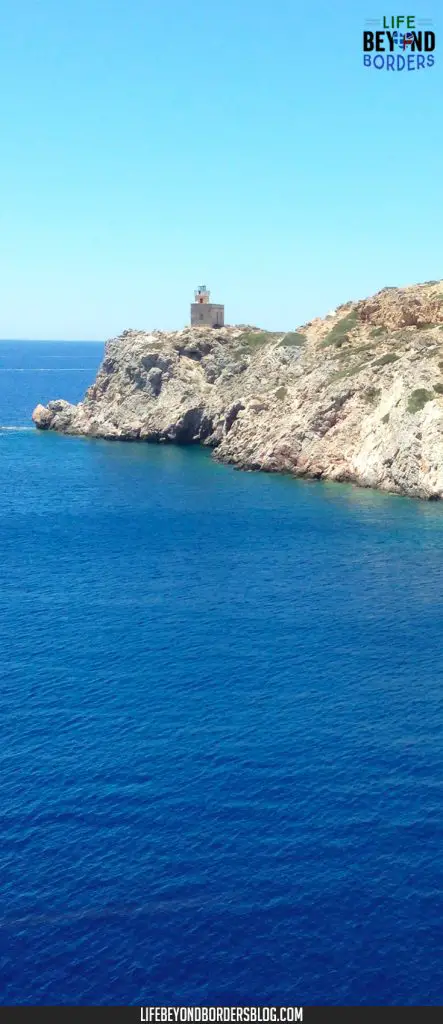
[33,282,443,499]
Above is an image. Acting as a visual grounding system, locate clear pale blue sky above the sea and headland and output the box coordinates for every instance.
[0,0,443,339]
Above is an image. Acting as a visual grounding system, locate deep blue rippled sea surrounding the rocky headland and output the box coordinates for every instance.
[0,342,443,1006]
